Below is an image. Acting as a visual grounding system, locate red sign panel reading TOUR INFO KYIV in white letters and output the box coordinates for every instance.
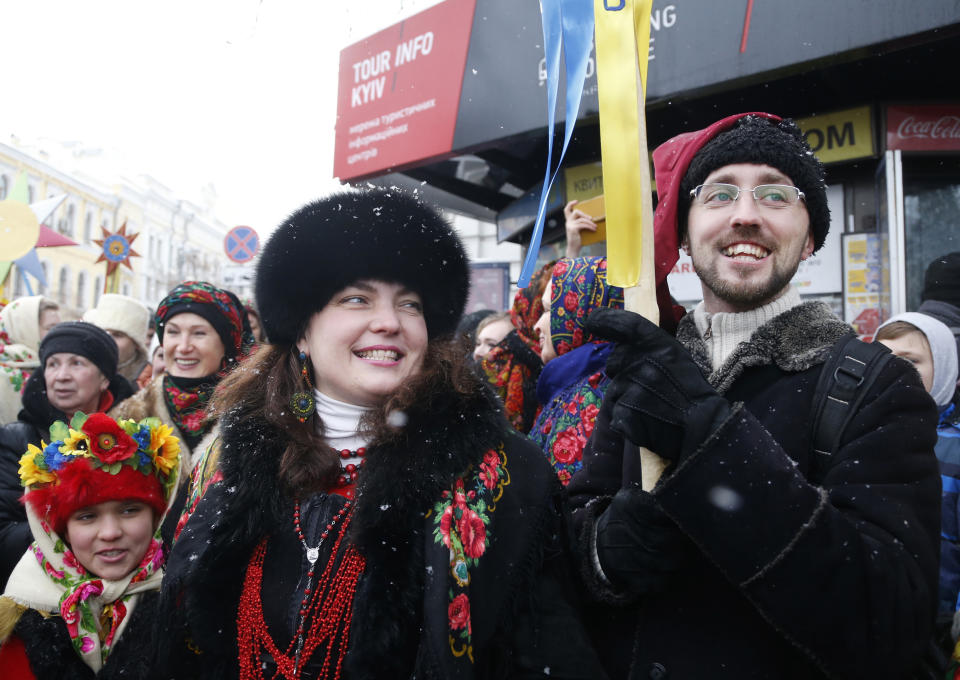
[333,0,476,180]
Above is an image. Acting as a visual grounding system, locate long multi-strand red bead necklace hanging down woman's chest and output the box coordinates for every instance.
[237,500,365,680]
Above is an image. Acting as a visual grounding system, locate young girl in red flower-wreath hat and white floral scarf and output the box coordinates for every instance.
[0,413,180,680]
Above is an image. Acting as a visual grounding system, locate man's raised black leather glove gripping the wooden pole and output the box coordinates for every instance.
[586,308,730,461]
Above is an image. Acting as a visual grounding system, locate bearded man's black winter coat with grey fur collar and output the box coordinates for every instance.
[568,303,940,679]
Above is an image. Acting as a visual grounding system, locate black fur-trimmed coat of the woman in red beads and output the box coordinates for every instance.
[156,372,604,680]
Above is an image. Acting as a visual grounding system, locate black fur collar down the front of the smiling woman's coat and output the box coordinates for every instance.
[168,372,509,677]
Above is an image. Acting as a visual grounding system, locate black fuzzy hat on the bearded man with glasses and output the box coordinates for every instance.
[677,116,830,251]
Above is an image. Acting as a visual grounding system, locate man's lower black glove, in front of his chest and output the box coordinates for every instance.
[597,489,693,595]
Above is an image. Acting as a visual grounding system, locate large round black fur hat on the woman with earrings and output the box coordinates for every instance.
[256,188,470,344]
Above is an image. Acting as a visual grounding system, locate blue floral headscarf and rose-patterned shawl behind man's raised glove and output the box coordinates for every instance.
[530,257,623,486]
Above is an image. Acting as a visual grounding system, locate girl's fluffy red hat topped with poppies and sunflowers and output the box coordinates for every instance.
[19,413,180,536]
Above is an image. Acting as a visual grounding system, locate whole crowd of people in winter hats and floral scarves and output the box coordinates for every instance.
[0,113,960,680]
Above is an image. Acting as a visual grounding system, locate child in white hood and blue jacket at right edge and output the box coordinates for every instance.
[875,312,960,637]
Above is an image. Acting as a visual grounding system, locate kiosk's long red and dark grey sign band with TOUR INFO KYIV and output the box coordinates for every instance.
[334,0,960,181]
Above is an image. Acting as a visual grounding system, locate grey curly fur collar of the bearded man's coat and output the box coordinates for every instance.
[677,302,853,394]
